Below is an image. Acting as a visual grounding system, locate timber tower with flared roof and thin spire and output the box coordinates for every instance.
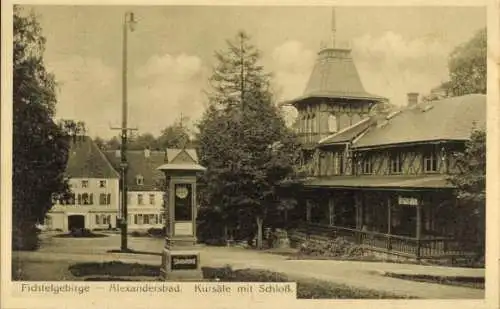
[290,9,384,146]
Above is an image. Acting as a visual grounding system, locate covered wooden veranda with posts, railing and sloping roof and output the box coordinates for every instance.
[285,175,478,259]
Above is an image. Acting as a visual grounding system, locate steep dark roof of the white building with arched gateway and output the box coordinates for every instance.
[65,136,120,178]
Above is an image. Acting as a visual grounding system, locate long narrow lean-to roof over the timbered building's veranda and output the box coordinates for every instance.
[303,175,453,190]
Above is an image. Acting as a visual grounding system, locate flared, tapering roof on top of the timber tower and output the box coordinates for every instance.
[291,48,384,104]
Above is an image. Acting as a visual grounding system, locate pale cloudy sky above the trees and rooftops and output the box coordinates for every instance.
[22,5,486,138]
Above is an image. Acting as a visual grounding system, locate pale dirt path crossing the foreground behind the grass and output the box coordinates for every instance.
[13,235,484,299]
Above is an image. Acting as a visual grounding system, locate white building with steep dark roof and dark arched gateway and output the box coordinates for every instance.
[45,137,119,231]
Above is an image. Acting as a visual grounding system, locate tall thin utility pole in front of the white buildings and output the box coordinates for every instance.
[112,12,137,251]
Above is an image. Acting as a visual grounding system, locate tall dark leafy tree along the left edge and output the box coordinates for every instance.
[12,7,69,249]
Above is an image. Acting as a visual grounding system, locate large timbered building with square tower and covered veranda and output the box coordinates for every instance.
[283,22,486,258]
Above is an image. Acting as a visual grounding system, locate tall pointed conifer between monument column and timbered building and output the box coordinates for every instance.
[198,32,296,247]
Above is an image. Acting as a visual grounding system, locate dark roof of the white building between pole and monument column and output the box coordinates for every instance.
[105,150,165,191]
